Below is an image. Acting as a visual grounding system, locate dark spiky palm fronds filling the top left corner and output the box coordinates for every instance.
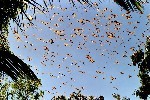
[0,0,45,31]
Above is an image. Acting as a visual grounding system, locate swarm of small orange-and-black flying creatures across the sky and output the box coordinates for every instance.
[8,2,150,96]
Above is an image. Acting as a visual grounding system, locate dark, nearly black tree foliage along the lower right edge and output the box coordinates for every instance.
[131,37,150,100]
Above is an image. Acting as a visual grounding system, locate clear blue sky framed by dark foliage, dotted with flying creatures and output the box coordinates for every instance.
[8,0,150,100]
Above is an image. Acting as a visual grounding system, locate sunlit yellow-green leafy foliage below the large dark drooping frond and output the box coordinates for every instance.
[0,78,44,100]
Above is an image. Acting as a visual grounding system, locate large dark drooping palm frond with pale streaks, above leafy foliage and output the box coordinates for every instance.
[0,50,38,80]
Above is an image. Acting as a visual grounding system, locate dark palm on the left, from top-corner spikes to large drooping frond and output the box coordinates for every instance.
[0,0,41,81]
